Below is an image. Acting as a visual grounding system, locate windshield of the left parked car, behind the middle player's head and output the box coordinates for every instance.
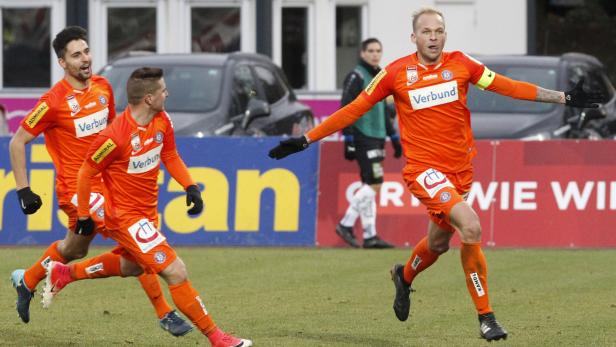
[102,66,222,112]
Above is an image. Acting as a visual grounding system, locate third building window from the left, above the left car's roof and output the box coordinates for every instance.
[190,7,241,52]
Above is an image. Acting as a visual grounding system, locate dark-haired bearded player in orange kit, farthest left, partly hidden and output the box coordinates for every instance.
[9,27,192,336]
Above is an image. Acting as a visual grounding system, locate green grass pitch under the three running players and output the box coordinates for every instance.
[0,248,616,347]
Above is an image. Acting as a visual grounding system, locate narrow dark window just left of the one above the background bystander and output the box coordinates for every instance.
[282,7,308,89]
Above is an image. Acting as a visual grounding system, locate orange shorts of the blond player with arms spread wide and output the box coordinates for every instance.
[403,168,473,232]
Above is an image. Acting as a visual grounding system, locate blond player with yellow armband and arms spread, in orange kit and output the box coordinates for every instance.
[269,8,602,341]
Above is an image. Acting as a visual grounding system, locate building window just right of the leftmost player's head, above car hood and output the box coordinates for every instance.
[107,7,157,61]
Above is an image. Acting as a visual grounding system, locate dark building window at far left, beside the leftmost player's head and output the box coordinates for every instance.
[0,7,51,88]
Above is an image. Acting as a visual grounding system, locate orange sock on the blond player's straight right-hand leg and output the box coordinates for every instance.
[460,242,492,314]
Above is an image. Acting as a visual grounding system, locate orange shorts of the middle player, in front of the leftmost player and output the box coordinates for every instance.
[108,218,177,273]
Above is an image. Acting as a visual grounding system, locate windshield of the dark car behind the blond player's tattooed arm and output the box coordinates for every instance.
[467,66,557,113]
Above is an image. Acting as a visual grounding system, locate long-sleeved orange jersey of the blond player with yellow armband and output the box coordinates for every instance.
[307,51,537,172]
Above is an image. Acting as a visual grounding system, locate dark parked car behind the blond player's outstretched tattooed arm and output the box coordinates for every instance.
[468,53,616,140]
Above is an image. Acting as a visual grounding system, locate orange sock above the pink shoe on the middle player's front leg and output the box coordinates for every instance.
[169,280,216,335]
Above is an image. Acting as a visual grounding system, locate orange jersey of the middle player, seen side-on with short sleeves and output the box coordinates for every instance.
[79,108,179,229]
